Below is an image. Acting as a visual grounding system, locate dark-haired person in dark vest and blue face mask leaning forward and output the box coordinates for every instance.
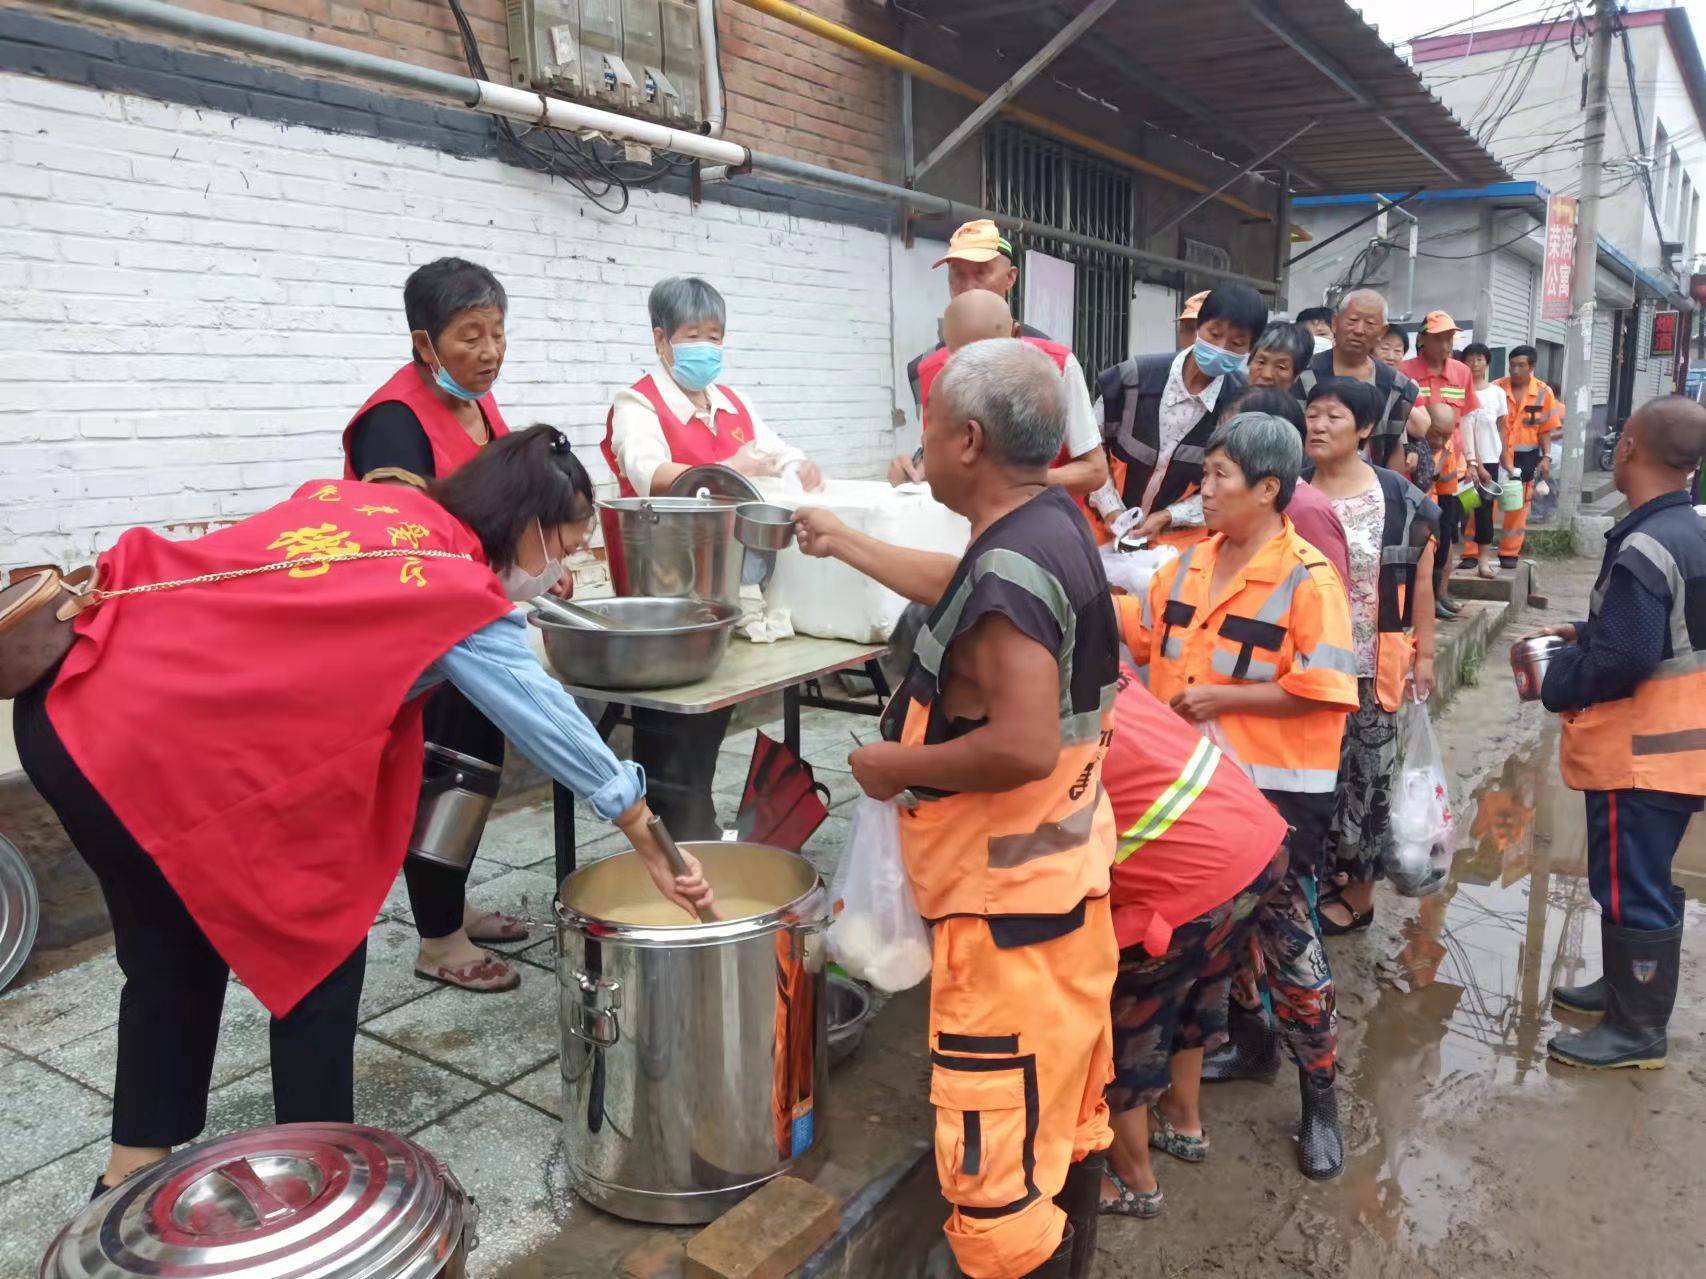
[1092,283,1268,546]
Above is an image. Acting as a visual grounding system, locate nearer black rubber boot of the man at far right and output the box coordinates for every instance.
[1546,921,1682,1071]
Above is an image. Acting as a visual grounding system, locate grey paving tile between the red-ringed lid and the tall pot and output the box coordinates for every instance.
[415,1093,573,1276]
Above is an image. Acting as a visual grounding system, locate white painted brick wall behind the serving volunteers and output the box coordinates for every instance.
[0,75,904,570]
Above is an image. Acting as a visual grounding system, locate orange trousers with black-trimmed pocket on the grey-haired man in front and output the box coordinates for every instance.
[930,897,1119,1279]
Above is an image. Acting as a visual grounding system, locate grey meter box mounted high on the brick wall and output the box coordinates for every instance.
[505,0,703,128]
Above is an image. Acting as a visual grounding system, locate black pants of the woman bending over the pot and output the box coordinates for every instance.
[12,675,367,1146]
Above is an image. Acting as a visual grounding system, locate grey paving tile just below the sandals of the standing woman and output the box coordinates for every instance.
[365,965,558,1083]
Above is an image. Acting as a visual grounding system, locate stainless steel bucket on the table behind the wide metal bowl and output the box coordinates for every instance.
[599,498,742,604]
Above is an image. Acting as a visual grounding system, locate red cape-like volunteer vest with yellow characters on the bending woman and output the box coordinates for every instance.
[48,481,510,1015]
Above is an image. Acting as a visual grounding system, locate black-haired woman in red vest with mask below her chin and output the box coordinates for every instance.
[343,258,527,993]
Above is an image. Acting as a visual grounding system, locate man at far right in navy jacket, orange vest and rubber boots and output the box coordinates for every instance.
[1541,396,1706,1069]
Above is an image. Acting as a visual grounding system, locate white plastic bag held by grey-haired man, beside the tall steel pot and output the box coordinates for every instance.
[829,795,930,991]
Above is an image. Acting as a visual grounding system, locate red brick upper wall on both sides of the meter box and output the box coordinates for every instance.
[80,0,899,177]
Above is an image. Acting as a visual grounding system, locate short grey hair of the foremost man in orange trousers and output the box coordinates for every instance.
[933,338,1066,467]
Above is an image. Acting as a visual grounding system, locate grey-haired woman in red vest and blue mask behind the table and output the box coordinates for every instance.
[604,276,824,839]
